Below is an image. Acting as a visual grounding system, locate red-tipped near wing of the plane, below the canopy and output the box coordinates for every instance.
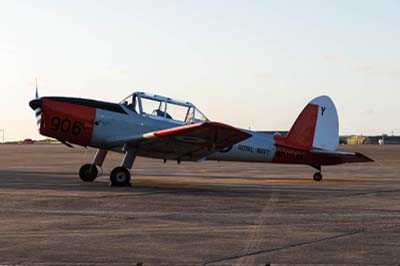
[106,122,251,161]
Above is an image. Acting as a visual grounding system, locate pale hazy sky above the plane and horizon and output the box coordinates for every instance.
[0,0,400,140]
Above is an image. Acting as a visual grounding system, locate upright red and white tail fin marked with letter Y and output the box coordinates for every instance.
[282,96,339,151]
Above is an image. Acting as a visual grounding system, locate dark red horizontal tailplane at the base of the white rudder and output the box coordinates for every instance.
[310,150,374,164]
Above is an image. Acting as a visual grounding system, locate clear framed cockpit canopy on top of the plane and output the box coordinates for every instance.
[121,92,208,124]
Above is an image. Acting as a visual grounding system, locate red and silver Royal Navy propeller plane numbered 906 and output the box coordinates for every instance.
[29,87,373,186]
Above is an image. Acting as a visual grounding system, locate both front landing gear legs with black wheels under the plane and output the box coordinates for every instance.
[79,147,136,187]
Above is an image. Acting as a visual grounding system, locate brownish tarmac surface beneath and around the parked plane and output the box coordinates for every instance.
[0,145,400,265]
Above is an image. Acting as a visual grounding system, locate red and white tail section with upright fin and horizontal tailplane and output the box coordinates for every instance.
[274,96,373,166]
